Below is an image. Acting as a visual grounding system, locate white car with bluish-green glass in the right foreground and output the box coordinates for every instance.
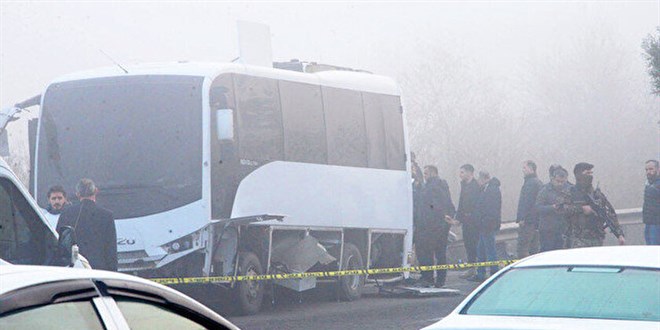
[425,246,660,330]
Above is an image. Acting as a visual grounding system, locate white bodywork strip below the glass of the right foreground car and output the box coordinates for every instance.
[424,314,658,330]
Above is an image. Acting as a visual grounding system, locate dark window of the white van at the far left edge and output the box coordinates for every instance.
[0,178,55,265]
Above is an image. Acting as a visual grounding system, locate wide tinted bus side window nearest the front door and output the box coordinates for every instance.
[234,75,284,160]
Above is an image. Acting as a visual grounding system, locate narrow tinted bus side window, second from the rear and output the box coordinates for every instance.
[362,93,387,168]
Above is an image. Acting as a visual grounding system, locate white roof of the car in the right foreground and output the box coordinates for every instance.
[513,245,660,269]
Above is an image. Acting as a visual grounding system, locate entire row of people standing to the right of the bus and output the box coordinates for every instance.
[412,154,660,287]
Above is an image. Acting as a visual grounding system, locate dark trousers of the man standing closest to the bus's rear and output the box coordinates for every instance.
[415,226,449,286]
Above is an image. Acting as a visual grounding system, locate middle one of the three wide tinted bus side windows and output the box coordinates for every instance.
[280,81,327,164]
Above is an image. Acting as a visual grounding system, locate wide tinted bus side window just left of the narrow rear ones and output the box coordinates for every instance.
[323,87,367,167]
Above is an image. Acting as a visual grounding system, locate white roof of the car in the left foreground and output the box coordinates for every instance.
[0,263,164,295]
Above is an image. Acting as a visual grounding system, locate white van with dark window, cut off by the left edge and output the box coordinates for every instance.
[0,159,89,268]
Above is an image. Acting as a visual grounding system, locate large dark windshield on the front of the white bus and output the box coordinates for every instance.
[35,75,203,219]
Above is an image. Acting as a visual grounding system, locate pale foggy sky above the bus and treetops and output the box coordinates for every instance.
[0,1,660,107]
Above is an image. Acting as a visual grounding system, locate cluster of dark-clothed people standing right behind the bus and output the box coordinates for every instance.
[412,153,502,287]
